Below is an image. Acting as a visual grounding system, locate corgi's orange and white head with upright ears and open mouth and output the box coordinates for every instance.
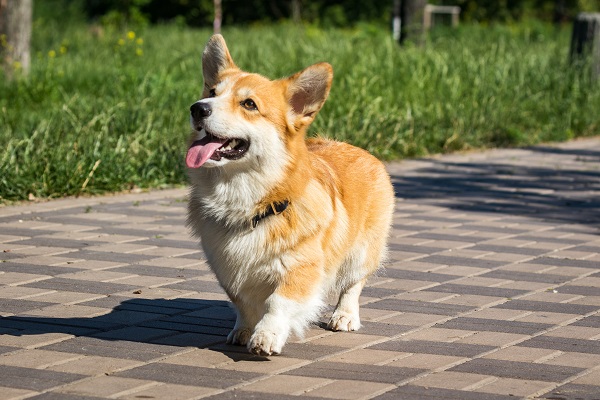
[186,35,333,169]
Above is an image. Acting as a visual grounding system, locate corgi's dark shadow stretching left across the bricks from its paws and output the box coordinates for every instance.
[0,299,274,361]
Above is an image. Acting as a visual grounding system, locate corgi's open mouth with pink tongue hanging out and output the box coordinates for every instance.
[185,132,250,168]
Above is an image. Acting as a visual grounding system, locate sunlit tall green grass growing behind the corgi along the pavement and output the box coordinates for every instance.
[0,19,600,202]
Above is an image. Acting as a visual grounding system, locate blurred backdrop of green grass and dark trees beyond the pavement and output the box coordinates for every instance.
[0,0,600,200]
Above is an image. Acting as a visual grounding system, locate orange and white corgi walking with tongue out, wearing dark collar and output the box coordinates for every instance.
[185,35,395,356]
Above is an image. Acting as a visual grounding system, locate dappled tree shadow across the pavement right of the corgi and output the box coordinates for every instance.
[392,147,600,228]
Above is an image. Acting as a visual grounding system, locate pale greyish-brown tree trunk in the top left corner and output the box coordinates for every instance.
[0,0,33,79]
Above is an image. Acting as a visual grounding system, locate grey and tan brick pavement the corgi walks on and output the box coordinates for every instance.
[0,138,600,400]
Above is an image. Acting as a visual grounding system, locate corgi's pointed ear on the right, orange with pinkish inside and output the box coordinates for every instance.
[287,62,333,129]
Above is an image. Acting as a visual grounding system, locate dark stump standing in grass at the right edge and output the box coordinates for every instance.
[570,13,600,79]
